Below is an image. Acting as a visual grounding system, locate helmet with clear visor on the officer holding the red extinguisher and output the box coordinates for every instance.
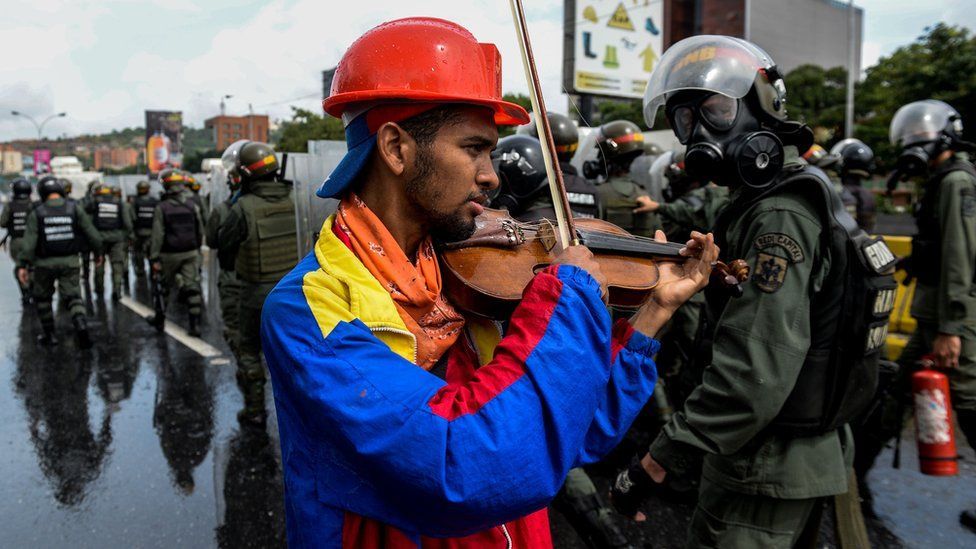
[888,99,972,176]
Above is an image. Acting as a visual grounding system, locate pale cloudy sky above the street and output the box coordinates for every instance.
[0,0,976,141]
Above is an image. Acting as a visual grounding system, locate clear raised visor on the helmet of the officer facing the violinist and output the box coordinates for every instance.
[644,35,774,127]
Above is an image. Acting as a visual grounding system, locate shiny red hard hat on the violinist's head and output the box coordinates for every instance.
[322,17,529,125]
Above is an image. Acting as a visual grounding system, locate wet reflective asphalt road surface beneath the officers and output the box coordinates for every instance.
[0,249,976,549]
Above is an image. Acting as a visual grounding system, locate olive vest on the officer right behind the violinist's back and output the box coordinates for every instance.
[235,195,298,284]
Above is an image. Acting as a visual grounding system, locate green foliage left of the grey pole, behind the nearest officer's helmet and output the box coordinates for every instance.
[786,65,847,138]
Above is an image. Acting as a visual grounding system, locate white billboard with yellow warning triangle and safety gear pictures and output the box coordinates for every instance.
[563,0,664,99]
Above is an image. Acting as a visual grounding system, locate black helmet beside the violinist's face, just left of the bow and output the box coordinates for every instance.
[491,134,546,212]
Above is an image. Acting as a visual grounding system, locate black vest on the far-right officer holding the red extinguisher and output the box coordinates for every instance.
[908,158,976,286]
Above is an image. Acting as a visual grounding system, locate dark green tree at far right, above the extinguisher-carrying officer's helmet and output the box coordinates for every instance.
[855,23,976,169]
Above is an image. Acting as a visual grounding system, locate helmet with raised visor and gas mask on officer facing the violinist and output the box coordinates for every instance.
[644,35,813,188]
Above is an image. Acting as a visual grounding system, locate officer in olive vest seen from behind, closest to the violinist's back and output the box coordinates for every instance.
[218,141,298,424]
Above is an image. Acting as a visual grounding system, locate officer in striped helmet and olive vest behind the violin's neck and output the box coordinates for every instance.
[584,120,660,237]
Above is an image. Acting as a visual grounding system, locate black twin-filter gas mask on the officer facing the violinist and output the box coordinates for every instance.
[667,92,784,189]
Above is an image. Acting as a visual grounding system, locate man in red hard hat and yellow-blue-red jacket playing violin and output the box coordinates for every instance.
[262,18,718,547]
